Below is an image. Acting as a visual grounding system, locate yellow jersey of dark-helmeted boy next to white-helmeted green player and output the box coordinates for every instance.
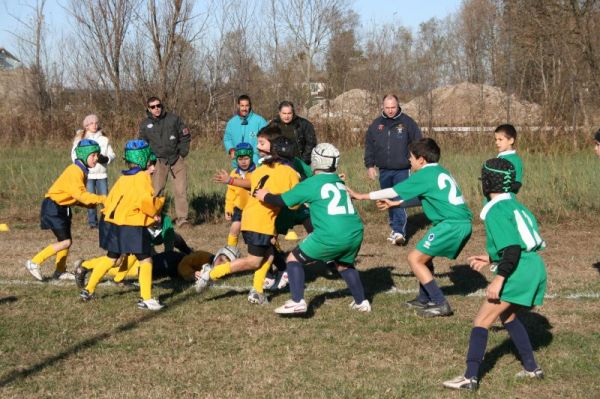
[242,162,300,236]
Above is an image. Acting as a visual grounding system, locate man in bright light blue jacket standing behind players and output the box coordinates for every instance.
[223,94,267,167]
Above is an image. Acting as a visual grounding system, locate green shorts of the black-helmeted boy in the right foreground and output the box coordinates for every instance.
[500,252,546,307]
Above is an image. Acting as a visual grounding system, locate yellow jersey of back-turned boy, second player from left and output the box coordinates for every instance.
[102,171,165,227]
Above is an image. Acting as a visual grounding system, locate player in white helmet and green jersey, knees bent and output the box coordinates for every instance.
[254,143,371,314]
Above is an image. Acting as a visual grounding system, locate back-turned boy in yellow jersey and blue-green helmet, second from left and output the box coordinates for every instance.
[80,140,165,310]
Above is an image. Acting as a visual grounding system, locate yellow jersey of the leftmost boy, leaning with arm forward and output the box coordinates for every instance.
[45,164,106,206]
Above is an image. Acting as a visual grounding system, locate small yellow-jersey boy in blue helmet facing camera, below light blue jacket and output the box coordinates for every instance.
[225,143,256,247]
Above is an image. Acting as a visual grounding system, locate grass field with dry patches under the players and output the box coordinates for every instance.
[0,142,600,398]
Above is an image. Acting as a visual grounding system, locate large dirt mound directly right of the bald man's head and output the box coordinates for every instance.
[402,82,542,126]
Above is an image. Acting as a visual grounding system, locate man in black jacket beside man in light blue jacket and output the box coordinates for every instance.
[272,101,317,165]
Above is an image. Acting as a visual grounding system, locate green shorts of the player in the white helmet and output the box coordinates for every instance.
[299,230,363,265]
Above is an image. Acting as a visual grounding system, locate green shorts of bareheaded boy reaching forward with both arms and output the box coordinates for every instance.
[416,221,471,259]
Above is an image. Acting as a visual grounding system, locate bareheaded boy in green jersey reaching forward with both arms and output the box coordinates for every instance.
[350,138,473,317]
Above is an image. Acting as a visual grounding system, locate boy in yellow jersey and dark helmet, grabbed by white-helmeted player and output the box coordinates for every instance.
[196,125,300,304]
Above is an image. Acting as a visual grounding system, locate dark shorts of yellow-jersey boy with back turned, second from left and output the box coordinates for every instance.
[99,220,152,259]
